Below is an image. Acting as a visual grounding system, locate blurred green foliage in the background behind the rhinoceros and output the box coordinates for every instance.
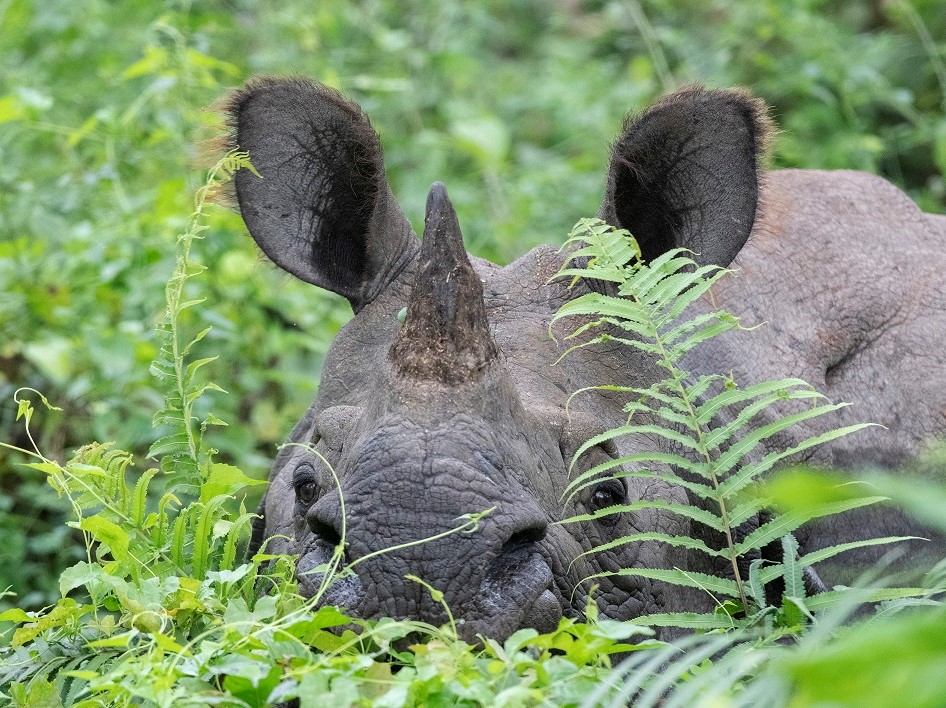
[0,0,946,607]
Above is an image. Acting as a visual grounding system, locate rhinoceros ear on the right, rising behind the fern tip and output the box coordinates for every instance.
[599,86,772,266]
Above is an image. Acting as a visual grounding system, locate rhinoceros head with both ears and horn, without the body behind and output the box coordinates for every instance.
[228,78,765,637]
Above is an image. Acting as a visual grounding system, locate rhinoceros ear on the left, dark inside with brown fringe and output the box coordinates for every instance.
[226,77,419,311]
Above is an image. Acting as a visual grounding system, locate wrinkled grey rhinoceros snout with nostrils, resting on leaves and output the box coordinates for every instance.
[297,486,562,641]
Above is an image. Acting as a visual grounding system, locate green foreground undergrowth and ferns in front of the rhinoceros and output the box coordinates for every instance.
[0,169,946,706]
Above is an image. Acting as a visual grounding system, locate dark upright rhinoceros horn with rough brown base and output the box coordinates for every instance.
[389,182,497,385]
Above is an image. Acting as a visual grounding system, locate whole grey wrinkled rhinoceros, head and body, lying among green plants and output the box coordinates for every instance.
[229,79,946,638]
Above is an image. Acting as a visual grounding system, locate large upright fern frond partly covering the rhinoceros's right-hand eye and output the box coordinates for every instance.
[553,220,880,624]
